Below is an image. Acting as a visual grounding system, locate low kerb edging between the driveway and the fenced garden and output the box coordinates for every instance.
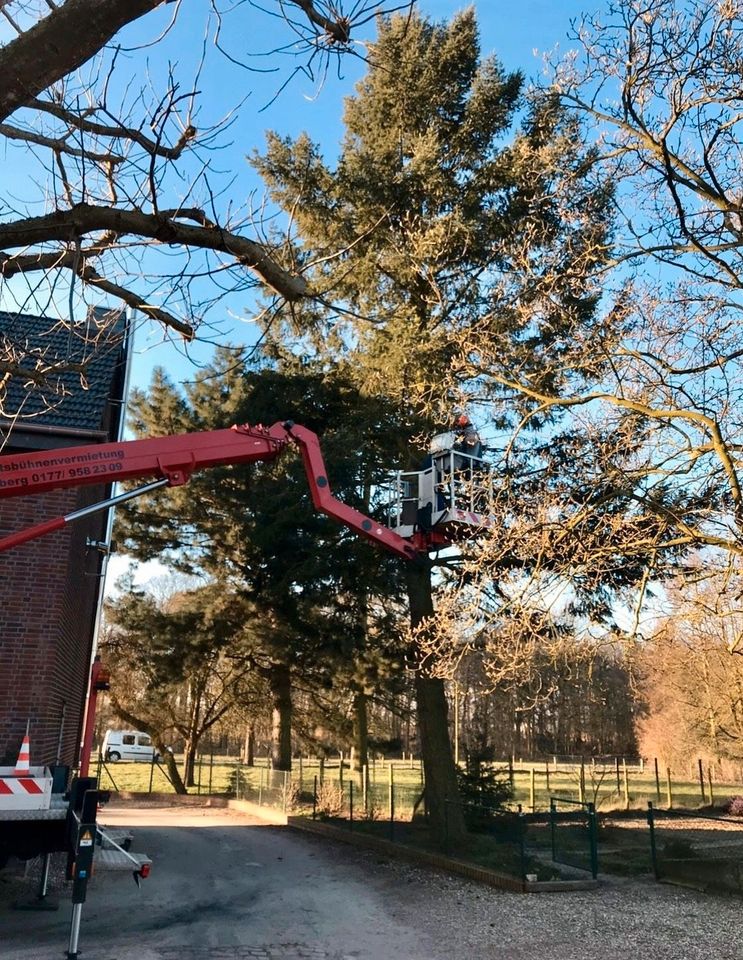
[287,817,598,893]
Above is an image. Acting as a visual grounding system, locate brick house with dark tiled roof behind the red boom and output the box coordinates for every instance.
[0,314,127,766]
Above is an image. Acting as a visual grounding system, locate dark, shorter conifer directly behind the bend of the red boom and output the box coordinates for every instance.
[119,349,410,769]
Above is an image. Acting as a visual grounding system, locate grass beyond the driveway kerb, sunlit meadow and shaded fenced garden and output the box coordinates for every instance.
[93,755,743,880]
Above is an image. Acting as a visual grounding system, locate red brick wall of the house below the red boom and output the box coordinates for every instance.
[0,487,105,765]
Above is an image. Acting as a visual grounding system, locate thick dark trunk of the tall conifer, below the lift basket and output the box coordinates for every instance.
[407,564,467,847]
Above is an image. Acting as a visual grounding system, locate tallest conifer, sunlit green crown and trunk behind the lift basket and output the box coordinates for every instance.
[253,8,610,835]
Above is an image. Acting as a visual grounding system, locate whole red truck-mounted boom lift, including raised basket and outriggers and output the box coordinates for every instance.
[0,421,489,960]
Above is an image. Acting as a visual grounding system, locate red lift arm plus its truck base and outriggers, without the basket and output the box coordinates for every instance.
[0,421,422,960]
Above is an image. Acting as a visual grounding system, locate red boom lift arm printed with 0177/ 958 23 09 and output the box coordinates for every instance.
[0,422,422,560]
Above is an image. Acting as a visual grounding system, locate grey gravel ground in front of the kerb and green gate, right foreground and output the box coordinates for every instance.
[348,853,743,960]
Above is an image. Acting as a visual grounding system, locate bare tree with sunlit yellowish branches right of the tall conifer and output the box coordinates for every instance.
[462,0,743,600]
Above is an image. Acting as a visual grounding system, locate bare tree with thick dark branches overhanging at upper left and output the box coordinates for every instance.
[0,0,407,416]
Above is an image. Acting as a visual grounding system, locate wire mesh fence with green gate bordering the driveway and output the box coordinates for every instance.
[90,754,743,894]
